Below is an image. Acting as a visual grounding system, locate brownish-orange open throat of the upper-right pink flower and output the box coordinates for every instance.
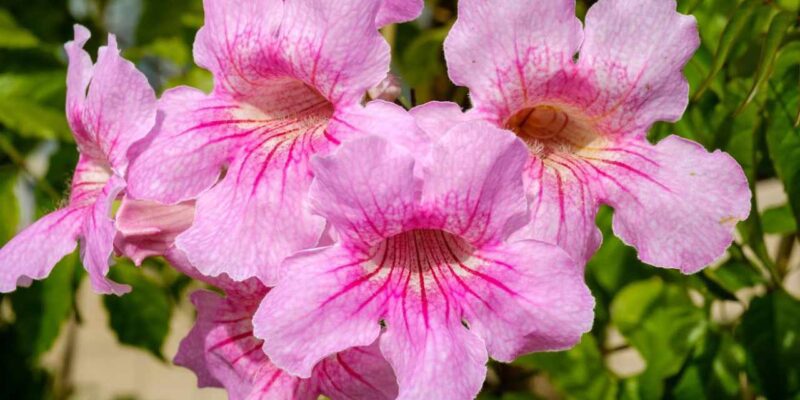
[505,104,600,160]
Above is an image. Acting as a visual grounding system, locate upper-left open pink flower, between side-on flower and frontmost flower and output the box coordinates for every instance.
[128,0,420,284]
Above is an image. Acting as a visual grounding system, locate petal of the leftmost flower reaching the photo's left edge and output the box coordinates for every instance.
[0,207,85,293]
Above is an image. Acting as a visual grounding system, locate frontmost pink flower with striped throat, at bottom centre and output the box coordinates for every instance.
[253,120,593,399]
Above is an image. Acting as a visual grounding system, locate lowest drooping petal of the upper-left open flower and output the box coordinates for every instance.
[176,135,325,285]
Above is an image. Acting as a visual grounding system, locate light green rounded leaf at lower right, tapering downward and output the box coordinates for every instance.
[611,278,707,398]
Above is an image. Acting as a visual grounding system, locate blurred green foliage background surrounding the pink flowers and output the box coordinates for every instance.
[0,0,800,400]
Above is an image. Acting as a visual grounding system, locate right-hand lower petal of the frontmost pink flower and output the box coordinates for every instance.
[462,240,594,362]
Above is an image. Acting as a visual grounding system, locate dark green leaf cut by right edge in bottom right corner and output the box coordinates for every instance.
[741,290,800,399]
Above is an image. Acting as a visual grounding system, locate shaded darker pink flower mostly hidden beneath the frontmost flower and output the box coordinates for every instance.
[175,279,397,400]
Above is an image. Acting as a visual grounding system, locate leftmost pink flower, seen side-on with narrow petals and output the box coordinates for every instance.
[0,25,156,294]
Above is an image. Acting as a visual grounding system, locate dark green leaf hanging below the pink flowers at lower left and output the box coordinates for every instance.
[103,261,172,360]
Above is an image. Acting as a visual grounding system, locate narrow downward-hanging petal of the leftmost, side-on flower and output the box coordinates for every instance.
[81,176,131,295]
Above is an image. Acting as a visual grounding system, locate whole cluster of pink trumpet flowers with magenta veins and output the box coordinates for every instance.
[0,0,750,399]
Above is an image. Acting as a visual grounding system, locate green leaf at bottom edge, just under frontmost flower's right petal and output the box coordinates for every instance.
[516,334,617,400]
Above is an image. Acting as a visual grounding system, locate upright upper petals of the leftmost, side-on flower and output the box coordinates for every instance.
[66,26,156,174]
